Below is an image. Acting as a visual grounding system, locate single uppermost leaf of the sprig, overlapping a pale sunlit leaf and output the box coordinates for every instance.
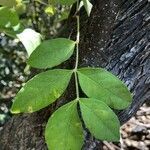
[28,38,75,68]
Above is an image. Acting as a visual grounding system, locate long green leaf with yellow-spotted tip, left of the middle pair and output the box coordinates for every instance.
[11,69,72,113]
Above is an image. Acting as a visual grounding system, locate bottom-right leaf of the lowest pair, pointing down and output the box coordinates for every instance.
[80,98,120,141]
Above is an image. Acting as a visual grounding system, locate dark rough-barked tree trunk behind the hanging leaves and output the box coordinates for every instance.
[0,0,150,150]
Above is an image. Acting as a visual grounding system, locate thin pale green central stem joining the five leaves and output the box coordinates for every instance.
[74,0,80,100]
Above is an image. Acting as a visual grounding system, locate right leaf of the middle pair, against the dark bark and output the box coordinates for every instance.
[78,68,132,109]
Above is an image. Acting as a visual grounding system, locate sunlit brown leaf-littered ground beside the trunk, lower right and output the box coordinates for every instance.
[103,104,150,150]
